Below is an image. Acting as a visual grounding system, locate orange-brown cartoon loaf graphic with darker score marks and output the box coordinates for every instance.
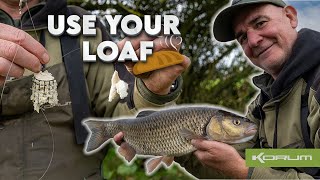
[133,51,184,75]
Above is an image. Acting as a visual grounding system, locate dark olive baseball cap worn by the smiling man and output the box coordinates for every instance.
[213,0,286,42]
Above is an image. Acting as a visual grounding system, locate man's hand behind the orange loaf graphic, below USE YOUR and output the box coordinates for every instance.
[118,33,190,95]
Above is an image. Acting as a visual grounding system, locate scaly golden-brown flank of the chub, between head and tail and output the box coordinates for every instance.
[114,108,217,156]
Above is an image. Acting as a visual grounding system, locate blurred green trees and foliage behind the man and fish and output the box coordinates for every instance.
[68,0,258,180]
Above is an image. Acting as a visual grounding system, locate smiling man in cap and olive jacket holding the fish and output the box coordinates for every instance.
[114,0,320,179]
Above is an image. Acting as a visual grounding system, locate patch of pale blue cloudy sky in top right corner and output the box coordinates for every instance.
[286,0,320,31]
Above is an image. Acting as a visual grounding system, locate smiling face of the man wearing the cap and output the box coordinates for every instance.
[233,4,298,79]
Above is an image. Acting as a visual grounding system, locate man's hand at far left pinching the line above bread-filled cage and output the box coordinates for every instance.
[0,23,49,85]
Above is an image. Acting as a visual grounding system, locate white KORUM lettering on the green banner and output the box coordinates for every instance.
[252,152,312,163]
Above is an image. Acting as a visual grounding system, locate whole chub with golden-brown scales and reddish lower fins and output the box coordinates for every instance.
[83,106,257,173]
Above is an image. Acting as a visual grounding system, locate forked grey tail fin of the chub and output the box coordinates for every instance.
[83,120,113,153]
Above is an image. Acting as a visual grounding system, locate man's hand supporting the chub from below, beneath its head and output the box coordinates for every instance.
[191,139,249,179]
